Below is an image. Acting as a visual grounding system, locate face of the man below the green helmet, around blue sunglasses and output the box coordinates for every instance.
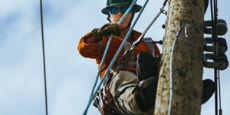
[109,5,132,29]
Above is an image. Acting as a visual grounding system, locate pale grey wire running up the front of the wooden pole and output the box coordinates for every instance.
[168,20,188,115]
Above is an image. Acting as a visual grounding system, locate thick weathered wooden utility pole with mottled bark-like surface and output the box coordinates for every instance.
[154,0,204,115]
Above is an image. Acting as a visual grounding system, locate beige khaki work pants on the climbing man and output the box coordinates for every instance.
[108,70,154,115]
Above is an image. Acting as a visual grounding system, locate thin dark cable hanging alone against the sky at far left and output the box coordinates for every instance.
[40,0,48,115]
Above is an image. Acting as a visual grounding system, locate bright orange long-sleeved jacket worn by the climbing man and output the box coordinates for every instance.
[78,30,161,79]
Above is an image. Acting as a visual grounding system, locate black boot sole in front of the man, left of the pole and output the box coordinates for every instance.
[137,51,158,112]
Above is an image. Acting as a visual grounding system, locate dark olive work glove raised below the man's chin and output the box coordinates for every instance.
[92,23,121,41]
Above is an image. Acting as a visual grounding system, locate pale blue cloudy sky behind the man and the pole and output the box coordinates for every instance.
[0,0,230,115]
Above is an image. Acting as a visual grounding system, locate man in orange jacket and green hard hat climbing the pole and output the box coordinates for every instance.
[78,0,216,115]
